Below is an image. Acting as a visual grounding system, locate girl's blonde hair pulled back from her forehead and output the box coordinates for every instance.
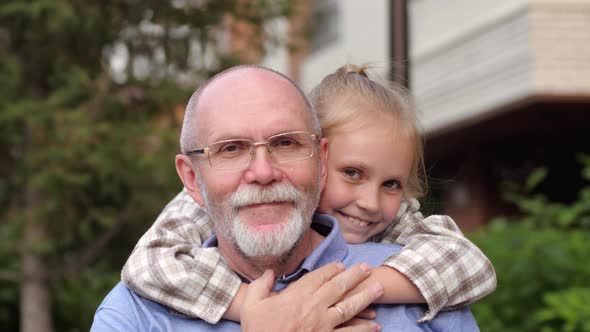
[309,64,426,198]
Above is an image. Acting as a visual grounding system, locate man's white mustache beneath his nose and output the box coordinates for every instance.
[229,183,300,209]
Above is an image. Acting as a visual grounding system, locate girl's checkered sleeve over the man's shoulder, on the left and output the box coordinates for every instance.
[121,190,240,324]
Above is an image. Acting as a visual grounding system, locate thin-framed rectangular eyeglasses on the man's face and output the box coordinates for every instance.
[185,131,318,170]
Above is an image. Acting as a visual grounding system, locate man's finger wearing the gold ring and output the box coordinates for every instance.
[328,283,383,326]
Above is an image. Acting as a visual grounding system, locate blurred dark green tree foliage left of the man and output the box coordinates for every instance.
[0,0,289,330]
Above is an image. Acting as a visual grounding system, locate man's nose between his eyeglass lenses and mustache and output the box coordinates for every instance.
[245,144,283,185]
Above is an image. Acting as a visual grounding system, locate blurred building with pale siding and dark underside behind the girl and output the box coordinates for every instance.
[267,0,590,230]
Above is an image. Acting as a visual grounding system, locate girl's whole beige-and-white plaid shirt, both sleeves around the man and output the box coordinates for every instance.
[121,190,496,324]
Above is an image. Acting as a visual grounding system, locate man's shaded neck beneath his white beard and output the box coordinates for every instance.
[217,229,324,280]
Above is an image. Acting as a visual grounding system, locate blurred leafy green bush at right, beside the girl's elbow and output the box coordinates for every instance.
[471,156,590,332]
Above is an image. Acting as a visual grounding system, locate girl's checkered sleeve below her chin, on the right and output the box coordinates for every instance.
[375,199,496,321]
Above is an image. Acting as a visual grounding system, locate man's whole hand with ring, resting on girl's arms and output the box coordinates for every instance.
[241,263,383,332]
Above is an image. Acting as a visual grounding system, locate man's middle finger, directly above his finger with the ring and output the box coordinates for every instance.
[314,263,371,307]
